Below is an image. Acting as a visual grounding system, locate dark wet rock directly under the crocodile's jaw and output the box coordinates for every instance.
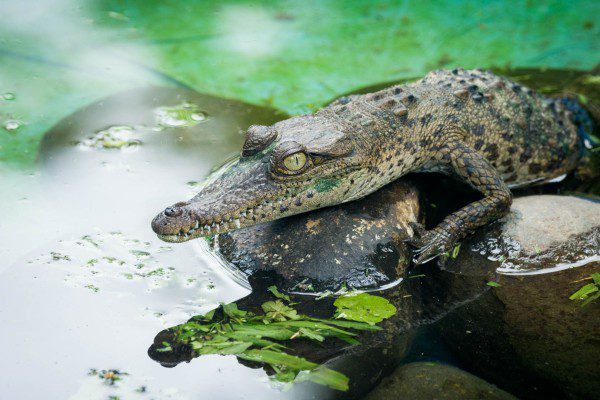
[218,181,419,291]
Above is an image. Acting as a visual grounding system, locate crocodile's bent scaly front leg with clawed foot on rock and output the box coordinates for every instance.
[411,140,512,264]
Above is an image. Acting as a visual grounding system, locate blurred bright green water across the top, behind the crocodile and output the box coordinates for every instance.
[0,0,600,167]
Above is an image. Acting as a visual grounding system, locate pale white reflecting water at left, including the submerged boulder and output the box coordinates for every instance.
[0,89,290,399]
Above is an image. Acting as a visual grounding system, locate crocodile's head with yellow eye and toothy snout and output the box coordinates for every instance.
[152,115,372,242]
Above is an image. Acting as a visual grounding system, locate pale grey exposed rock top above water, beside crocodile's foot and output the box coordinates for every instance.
[446,195,600,275]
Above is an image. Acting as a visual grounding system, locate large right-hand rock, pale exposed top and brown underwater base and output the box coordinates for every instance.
[438,195,600,399]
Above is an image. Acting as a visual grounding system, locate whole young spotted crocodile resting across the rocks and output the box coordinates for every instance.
[152,68,587,264]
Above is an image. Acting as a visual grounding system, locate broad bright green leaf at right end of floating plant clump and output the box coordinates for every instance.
[333,293,396,324]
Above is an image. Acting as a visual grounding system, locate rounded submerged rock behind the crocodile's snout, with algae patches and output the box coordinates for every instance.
[38,86,287,169]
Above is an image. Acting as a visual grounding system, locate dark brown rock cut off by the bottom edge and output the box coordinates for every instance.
[365,362,516,400]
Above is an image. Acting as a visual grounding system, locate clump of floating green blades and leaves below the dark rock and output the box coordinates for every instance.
[157,286,396,391]
